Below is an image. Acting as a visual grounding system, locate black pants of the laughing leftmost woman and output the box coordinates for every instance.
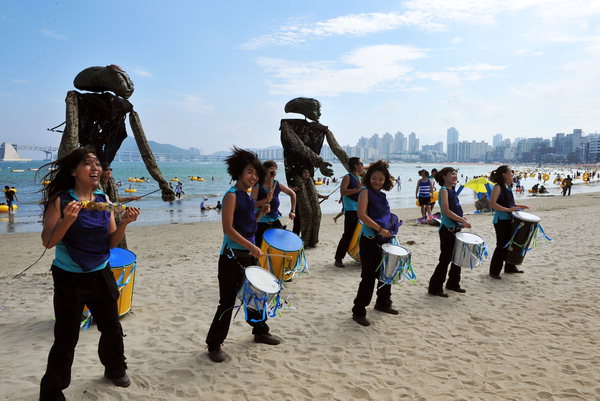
[40,266,127,400]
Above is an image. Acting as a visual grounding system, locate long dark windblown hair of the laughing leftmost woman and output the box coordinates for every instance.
[36,146,96,216]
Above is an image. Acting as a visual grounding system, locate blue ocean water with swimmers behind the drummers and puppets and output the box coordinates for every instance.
[0,161,600,234]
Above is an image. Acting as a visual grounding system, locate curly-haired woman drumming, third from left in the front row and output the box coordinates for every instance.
[352,160,398,326]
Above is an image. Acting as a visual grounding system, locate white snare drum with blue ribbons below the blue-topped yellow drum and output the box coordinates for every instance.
[238,266,282,320]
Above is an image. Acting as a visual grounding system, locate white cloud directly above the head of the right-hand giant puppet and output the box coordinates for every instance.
[257,45,425,96]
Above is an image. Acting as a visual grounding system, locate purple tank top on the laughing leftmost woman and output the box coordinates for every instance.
[59,193,110,271]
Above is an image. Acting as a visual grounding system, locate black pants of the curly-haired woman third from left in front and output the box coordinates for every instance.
[352,236,392,317]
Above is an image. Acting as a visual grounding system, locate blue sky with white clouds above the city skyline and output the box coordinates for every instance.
[0,0,600,153]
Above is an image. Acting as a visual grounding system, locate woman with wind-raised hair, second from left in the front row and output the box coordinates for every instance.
[206,147,281,362]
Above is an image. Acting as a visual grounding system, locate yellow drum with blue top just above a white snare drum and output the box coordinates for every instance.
[259,228,308,281]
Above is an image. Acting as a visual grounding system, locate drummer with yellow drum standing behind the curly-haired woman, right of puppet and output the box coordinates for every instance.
[335,157,364,267]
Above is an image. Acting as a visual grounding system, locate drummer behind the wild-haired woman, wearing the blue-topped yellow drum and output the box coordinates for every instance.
[252,160,296,248]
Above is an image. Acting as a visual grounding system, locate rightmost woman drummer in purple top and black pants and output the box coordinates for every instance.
[490,165,529,280]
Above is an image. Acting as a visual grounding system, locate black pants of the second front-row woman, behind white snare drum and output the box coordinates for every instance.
[206,255,269,351]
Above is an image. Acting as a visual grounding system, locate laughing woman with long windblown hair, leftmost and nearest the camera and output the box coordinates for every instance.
[40,147,140,400]
